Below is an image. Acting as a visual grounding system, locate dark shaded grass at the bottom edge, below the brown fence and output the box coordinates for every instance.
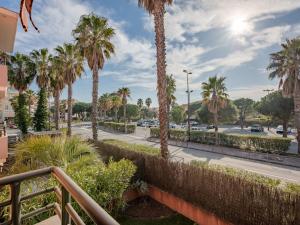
[118,214,196,225]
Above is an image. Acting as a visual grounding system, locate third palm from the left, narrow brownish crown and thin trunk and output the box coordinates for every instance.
[50,56,65,130]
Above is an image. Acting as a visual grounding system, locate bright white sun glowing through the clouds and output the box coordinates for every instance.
[230,15,252,36]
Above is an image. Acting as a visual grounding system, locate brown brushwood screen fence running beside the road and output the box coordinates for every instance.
[96,142,300,225]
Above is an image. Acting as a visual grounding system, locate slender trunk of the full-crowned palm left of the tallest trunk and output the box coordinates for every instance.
[92,54,99,141]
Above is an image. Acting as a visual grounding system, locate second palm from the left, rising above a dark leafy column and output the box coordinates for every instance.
[30,48,52,130]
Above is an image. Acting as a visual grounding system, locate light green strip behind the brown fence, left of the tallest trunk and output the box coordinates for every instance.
[103,139,160,155]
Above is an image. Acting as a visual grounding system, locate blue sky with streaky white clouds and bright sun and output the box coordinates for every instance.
[0,0,300,106]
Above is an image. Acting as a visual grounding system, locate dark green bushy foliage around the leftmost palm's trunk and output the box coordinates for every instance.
[15,94,30,134]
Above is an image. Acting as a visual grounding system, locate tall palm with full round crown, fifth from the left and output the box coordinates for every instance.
[73,13,115,141]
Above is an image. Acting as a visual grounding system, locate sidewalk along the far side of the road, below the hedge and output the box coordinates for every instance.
[147,138,300,168]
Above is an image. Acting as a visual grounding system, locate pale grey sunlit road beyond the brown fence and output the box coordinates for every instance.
[72,125,300,184]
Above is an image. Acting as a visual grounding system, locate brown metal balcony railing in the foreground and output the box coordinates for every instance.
[0,167,119,225]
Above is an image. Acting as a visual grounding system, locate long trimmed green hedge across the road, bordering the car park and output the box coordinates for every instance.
[150,128,291,154]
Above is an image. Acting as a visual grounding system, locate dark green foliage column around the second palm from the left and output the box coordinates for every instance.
[33,88,48,131]
